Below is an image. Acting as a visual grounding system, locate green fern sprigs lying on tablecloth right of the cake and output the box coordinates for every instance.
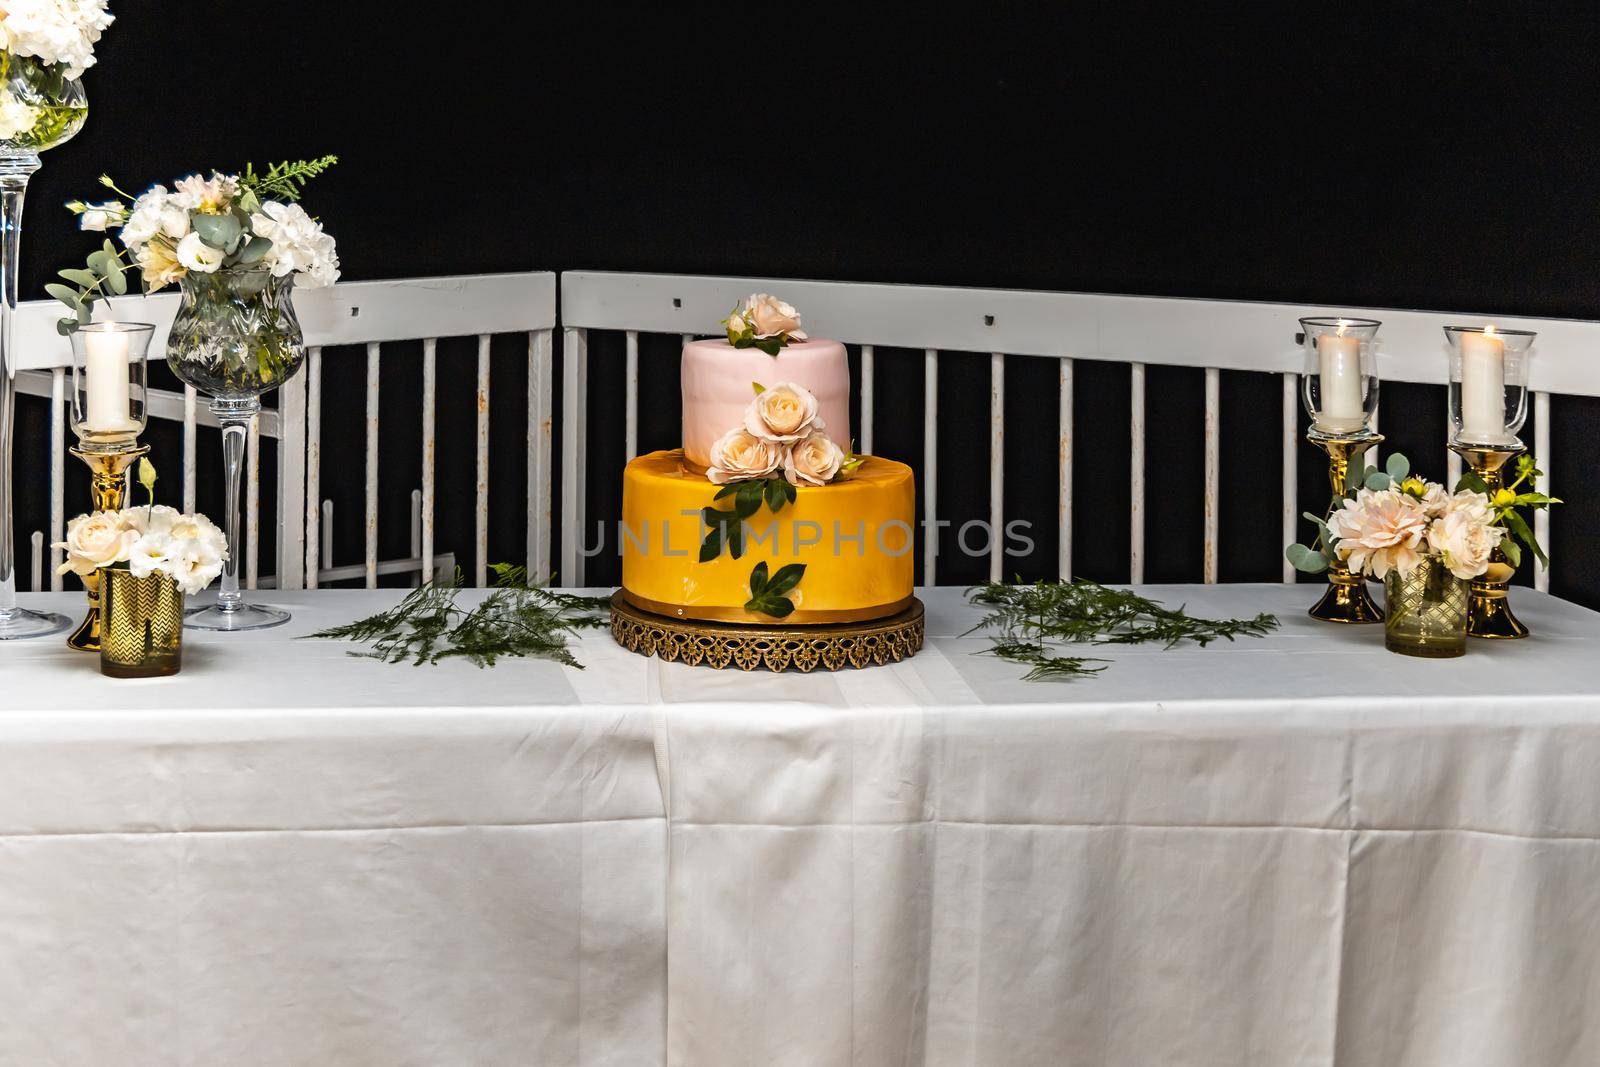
[966,581,1278,681]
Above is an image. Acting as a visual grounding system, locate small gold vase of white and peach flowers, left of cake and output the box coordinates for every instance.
[54,459,227,678]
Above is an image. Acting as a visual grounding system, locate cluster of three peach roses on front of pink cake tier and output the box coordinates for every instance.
[706,382,861,486]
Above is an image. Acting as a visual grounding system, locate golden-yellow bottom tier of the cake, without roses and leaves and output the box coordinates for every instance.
[621,451,917,625]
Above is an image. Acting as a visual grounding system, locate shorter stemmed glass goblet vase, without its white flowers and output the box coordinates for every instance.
[166,269,306,630]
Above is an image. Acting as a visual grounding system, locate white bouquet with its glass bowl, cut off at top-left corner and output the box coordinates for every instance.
[0,0,112,152]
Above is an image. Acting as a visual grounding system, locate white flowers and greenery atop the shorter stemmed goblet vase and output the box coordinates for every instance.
[55,158,339,333]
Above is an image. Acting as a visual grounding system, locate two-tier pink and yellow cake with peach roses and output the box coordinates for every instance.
[619,294,920,659]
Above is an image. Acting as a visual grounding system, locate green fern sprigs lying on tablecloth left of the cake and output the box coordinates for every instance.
[309,563,611,669]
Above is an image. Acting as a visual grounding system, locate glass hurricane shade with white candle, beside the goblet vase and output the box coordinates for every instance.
[72,322,155,454]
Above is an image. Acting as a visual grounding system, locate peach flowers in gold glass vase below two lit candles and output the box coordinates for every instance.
[1288,454,1560,657]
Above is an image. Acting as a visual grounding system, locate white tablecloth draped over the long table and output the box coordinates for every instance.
[0,585,1600,1067]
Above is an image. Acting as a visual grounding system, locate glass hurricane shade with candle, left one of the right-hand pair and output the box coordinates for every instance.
[1301,317,1382,437]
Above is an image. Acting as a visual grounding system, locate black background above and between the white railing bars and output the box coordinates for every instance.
[18,0,1600,603]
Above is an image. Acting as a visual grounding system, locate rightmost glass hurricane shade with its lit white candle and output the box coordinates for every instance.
[1445,326,1538,450]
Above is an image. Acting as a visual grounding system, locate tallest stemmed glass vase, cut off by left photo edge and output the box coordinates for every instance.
[0,51,88,641]
